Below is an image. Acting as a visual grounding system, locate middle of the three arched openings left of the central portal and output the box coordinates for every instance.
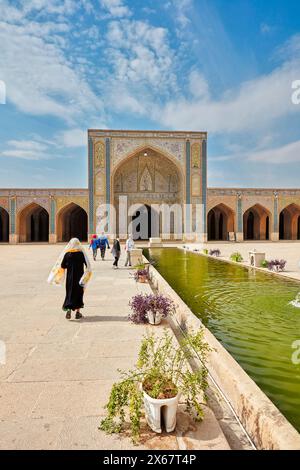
[18,203,49,243]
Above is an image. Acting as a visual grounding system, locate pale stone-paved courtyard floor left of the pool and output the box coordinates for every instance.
[0,245,229,449]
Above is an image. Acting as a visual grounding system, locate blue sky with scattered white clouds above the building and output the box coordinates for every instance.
[0,0,300,187]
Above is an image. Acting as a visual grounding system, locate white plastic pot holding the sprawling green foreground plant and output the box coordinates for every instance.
[144,392,180,433]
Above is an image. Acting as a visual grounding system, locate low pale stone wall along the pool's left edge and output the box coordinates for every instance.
[150,266,300,450]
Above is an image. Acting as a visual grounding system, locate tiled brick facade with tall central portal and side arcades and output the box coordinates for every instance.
[0,130,300,243]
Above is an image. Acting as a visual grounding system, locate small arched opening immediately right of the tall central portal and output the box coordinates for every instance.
[207,204,234,241]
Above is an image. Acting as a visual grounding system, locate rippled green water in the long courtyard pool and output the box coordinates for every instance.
[145,248,300,431]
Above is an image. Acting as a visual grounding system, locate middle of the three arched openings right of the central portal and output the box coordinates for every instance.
[244,204,271,240]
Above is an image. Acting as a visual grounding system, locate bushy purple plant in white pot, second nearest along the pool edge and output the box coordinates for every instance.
[128,294,175,325]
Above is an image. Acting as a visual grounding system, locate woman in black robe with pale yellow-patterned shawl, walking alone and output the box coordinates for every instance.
[48,238,92,320]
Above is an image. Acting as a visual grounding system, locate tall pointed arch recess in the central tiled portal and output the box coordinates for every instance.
[112,147,183,239]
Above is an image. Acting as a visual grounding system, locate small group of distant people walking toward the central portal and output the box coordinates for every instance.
[89,232,134,269]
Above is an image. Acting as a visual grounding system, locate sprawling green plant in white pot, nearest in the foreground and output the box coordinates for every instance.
[100,329,210,443]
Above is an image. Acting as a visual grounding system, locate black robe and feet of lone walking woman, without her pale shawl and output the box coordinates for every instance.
[61,250,87,320]
